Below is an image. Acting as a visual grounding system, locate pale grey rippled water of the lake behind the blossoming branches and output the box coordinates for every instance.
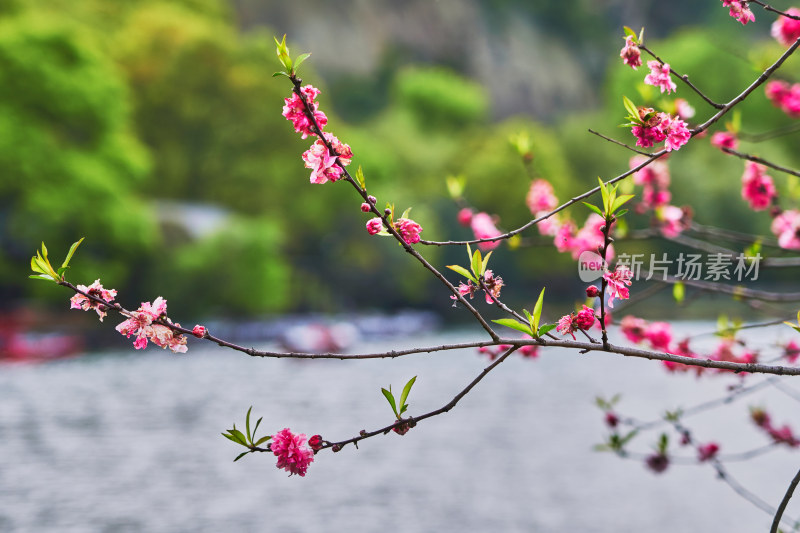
[0,325,800,533]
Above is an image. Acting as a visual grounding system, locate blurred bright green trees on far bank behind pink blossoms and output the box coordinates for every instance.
[0,0,800,319]
